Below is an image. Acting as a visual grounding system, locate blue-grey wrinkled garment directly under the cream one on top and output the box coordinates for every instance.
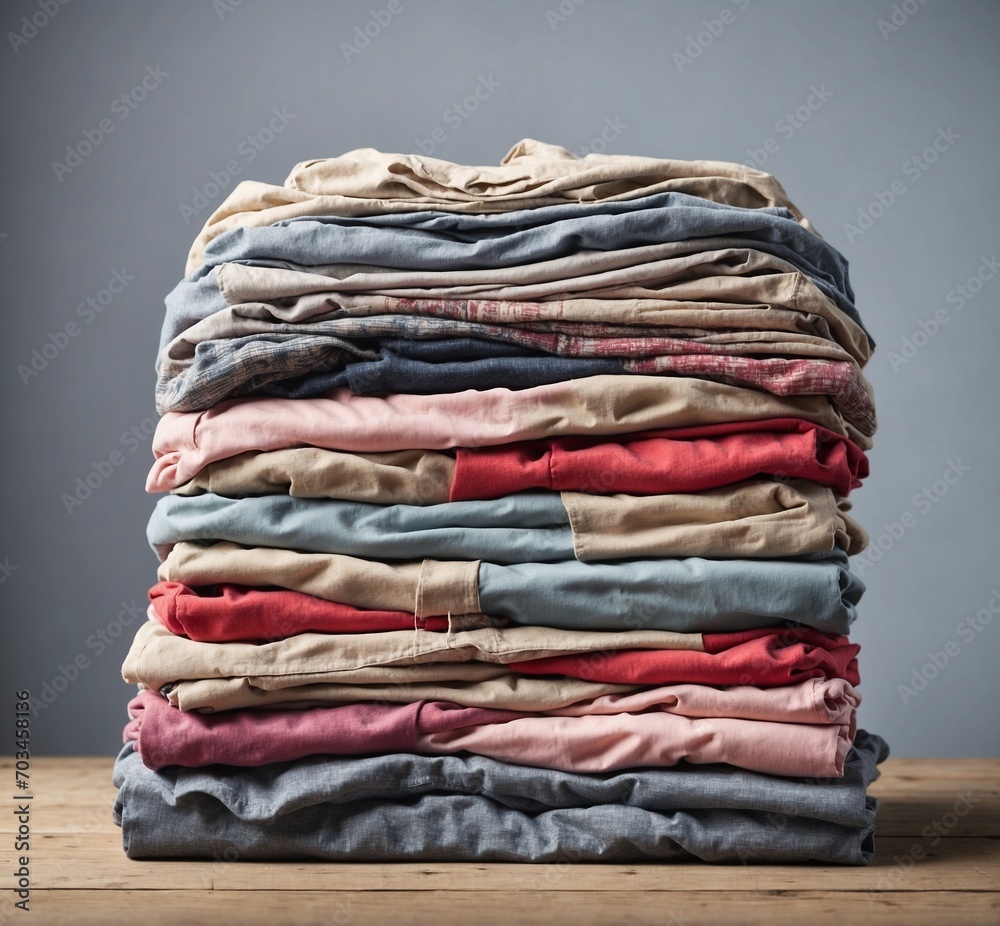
[203,192,850,298]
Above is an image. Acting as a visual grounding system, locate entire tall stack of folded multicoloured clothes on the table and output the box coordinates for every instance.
[115,141,887,864]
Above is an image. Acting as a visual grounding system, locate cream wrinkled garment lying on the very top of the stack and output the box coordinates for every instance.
[185,138,815,274]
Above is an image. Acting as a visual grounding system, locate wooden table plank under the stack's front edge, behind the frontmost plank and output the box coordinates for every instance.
[0,833,1000,892]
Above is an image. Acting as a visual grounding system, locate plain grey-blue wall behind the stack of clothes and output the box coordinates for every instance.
[0,0,1000,756]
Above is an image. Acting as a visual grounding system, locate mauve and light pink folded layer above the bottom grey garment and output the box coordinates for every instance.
[124,679,860,777]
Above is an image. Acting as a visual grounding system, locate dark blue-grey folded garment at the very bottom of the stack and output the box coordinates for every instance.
[114,731,888,865]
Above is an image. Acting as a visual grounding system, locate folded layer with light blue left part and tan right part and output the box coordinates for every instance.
[146,480,867,563]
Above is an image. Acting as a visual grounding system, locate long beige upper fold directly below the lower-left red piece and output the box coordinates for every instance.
[122,617,705,690]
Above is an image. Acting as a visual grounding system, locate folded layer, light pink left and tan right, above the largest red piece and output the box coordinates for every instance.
[146,376,871,492]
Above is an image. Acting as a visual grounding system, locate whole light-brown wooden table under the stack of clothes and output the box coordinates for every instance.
[0,757,1000,926]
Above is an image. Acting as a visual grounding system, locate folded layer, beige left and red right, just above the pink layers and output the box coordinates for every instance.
[122,620,859,691]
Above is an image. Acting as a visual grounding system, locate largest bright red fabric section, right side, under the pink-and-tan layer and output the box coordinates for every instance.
[450,418,868,501]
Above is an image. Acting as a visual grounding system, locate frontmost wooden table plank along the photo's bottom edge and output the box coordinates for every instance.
[13,890,1000,926]
